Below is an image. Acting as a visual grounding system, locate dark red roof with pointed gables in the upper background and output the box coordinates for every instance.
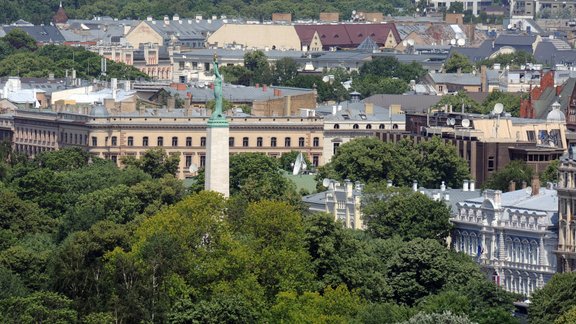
[294,23,401,48]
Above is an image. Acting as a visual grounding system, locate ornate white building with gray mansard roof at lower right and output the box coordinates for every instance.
[451,180,559,296]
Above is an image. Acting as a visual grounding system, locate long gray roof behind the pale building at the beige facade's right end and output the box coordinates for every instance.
[362,94,442,113]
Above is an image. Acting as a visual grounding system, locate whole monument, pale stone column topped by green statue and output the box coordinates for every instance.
[204,56,230,197]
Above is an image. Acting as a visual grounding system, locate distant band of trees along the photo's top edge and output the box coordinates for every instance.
[0,0,415,24]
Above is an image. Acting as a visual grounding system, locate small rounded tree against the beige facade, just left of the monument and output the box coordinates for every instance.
[122,148,180,178]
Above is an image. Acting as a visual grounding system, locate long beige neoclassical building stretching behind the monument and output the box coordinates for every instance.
[0,106,325,178]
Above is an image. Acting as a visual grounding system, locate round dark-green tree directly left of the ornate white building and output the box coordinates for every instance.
[363,188,452,242]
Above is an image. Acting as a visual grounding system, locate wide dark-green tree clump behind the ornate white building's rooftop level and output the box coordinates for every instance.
[319,137,469,188]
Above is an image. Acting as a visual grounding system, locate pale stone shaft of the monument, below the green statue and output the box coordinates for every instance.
[204,121,230,197]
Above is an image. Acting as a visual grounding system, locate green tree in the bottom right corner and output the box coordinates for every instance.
[528,272,576,324]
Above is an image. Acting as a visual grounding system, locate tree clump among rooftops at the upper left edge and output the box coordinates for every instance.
[0,29,148,80]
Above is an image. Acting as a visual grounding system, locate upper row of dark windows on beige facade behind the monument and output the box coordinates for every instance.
[92,136,320,147]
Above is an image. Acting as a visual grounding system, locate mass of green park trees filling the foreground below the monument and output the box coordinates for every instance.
[0,143,518,323]
